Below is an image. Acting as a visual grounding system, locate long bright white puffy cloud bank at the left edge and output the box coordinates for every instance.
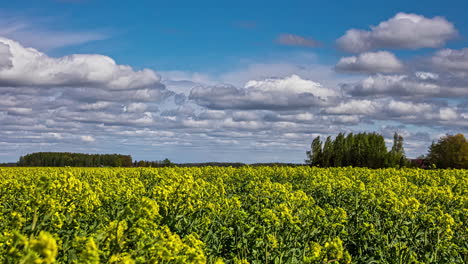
[0,38,160,90]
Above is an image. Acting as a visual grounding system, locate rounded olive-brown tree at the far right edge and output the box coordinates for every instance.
[427,134,468,169]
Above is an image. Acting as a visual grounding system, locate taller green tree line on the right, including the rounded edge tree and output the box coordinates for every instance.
[306,133,468,169]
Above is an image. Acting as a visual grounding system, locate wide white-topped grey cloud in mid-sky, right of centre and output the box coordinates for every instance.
[189,75,338,109]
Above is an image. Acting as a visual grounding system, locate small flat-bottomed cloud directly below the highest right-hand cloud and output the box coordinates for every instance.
[335,51,403,73]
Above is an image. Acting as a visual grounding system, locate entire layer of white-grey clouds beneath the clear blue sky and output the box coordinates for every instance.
[0,9,468,162]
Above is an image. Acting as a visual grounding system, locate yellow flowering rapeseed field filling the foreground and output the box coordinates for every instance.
[0,167,468,263]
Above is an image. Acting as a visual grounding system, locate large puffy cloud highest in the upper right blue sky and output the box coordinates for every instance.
[337,13,458,53]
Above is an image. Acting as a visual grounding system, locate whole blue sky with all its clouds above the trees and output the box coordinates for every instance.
[0,0,468,163]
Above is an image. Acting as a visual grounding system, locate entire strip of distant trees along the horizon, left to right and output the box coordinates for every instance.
[0,133,468,169]
